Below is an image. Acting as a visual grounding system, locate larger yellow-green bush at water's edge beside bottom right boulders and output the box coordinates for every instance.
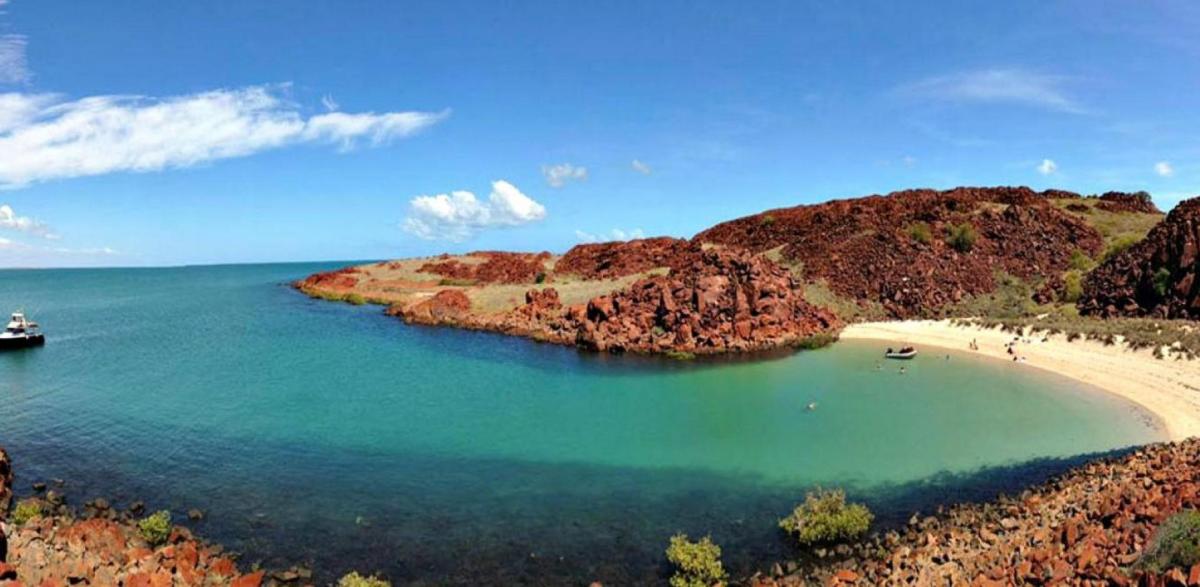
[779,489,875,546]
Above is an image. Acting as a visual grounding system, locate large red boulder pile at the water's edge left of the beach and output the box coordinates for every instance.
[564,250,839,353]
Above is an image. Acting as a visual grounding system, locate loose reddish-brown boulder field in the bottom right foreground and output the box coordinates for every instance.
[746,439,1200,587]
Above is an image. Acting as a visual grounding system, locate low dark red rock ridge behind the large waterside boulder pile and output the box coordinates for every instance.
[554,236,694,280]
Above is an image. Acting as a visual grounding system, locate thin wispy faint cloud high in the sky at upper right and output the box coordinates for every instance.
[899,68,1085,114]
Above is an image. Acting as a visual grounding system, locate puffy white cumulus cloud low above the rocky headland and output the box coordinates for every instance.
[401,179,546,242]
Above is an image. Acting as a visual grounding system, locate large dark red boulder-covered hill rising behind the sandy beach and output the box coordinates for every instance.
[695,187,1103,318]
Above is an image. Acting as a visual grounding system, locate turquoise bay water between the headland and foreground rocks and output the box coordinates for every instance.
[0,264,1160,585]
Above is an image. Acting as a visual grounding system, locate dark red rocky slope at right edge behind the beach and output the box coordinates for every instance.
[1079,198,1200,319]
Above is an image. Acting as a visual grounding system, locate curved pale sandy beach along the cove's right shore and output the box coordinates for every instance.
[841,321,1200,441]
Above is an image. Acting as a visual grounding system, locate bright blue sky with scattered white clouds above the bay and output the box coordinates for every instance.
[0,0,1200,266]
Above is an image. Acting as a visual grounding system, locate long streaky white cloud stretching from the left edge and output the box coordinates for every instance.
[0,86,448,187]
